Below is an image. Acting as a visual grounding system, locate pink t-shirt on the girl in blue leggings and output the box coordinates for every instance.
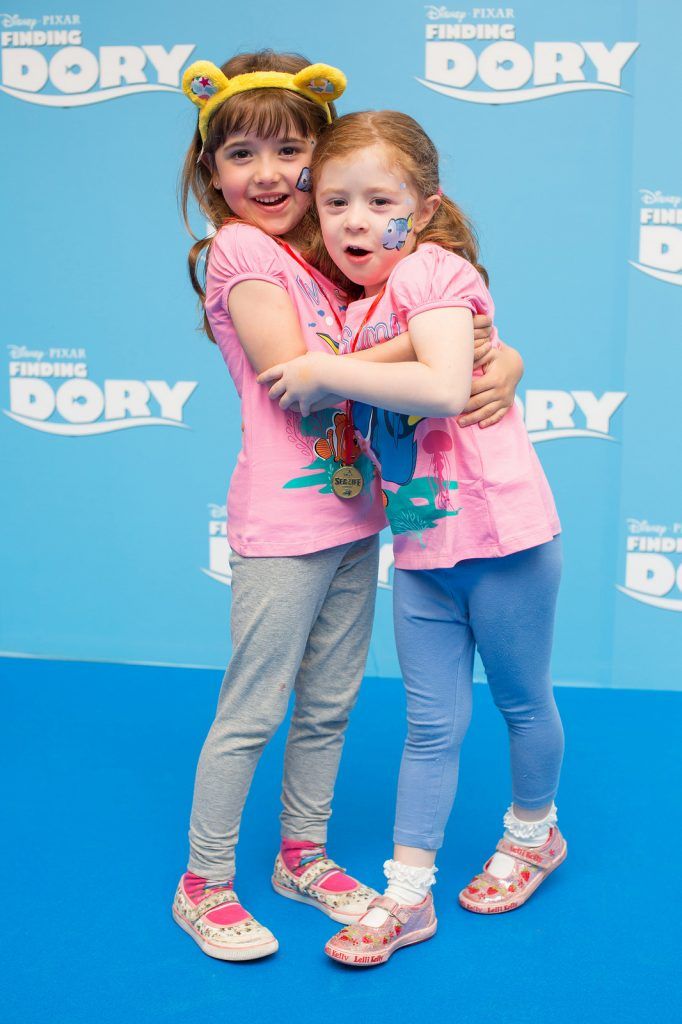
[341,244,561,569]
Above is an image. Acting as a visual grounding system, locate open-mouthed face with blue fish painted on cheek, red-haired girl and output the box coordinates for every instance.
[315,145,438,295]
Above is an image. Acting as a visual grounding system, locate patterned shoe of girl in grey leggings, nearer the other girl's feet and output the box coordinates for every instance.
[272,854,379,925]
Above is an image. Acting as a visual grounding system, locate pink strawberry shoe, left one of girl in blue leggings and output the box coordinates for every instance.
[325,893,437,967]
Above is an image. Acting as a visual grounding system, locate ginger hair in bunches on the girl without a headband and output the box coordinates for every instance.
[305,111,487,284]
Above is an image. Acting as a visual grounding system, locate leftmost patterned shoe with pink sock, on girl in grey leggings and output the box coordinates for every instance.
[173,874,279,961]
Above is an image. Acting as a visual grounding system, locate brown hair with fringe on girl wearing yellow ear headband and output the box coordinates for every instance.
[179,50,339,341]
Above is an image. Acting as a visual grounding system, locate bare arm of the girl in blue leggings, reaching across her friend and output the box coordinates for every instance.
[259,306,473,416]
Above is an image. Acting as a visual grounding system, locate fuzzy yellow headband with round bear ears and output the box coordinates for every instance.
[182,60,346,142]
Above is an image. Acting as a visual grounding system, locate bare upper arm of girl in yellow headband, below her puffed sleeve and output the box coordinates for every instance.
[227,281,306,374]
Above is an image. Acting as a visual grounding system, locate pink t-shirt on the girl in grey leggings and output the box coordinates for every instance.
[206,223,386,556]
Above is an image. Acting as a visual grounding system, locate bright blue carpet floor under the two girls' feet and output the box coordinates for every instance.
[0,659,682,1024]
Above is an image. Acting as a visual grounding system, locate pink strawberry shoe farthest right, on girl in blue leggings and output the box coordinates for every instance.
[460,826,567,913]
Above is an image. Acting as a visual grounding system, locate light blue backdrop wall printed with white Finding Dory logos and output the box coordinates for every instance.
[0,0,682,689]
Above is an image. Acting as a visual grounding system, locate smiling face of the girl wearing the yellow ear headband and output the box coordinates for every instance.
[213,132,314,236]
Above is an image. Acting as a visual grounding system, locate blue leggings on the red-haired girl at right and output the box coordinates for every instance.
[393,537,563,850]
